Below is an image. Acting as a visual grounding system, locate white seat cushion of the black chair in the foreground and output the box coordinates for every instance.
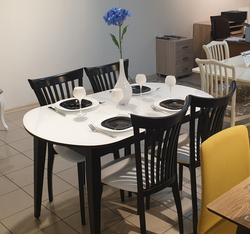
[101,154,137,192]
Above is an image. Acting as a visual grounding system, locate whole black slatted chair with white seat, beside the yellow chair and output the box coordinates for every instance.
[177,81,236,233]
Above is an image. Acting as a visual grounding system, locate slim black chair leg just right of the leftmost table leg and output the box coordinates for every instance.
[47,143,56,202]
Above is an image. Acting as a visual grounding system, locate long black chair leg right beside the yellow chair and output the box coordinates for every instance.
[190,168,198,234]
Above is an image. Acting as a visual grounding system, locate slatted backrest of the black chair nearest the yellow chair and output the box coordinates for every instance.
[189,81,236,167]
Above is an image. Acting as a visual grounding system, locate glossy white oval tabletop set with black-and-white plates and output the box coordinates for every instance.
[23,83,211,146]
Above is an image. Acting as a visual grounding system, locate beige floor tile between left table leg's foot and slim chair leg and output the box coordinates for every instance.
[43,188,84,219]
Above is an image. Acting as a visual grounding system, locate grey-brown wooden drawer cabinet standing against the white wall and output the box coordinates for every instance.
[156,38,194,77]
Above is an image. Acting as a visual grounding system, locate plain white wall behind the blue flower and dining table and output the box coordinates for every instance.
[0,0,250,109]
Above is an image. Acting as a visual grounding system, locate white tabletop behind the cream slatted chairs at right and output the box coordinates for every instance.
[192,55,250,86]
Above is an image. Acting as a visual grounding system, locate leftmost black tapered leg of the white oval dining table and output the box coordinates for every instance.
[34,137,46,218]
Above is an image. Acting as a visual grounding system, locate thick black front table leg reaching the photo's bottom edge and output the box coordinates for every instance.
[86,151,102,234]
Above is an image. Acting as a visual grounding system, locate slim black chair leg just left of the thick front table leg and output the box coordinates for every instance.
[77,162,86,225]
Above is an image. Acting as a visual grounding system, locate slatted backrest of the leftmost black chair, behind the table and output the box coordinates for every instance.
[28,68,83,106]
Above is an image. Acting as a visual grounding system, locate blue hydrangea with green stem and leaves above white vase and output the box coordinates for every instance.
[103,8,131,59]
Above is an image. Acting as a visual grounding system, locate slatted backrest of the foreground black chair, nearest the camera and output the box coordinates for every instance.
[131,97,189,196]
